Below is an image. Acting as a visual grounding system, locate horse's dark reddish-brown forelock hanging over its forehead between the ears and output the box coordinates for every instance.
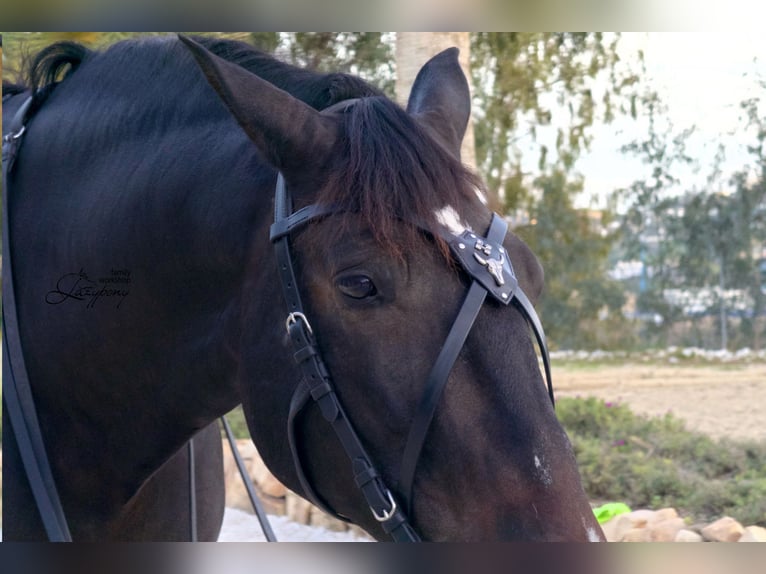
[312,97,483,255]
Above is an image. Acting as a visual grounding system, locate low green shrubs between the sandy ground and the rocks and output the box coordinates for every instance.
[557,398,766,525]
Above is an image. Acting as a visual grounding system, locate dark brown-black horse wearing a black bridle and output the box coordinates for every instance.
[3,37,601,541]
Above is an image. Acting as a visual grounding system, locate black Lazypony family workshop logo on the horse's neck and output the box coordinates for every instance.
[45,269,131,309]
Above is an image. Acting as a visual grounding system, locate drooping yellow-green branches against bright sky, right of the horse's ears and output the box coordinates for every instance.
[471,32,639,209]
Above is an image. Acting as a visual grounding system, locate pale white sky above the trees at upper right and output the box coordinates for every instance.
[578,31,766,207]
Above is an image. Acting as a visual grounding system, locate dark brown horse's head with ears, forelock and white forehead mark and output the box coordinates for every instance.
[182,38,602,541]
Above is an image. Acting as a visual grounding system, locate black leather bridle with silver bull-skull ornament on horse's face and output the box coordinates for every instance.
[270,169,554,542]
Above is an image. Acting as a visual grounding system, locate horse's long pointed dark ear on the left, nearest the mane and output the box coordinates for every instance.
[178,34,338,179]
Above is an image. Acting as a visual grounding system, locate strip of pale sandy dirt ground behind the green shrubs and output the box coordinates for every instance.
[553,361,766,440]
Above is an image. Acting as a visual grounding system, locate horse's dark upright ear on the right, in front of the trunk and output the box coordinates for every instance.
[407,48,471,158]
